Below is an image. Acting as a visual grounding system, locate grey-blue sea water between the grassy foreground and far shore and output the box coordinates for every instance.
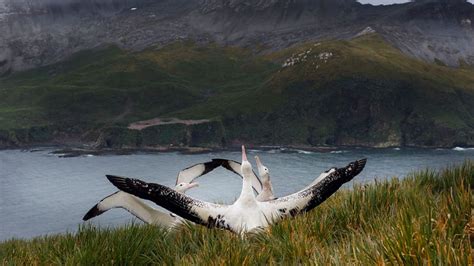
[0,148,474,241]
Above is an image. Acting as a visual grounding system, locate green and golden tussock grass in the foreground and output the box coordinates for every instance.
[0,161,474,265]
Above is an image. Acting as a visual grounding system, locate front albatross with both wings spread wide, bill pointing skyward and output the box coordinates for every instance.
[107,146,367,234]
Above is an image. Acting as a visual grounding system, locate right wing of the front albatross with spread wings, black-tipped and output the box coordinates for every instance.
[261,159,367,218]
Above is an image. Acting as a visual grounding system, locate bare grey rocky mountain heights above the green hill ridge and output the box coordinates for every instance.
[0,0,474,75]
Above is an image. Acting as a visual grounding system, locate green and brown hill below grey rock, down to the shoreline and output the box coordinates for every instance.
[0,34,474,148]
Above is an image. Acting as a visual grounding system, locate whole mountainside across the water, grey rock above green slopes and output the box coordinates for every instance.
[0,0,474,148]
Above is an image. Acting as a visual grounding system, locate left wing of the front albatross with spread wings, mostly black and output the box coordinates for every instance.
[107,175,228,228]
